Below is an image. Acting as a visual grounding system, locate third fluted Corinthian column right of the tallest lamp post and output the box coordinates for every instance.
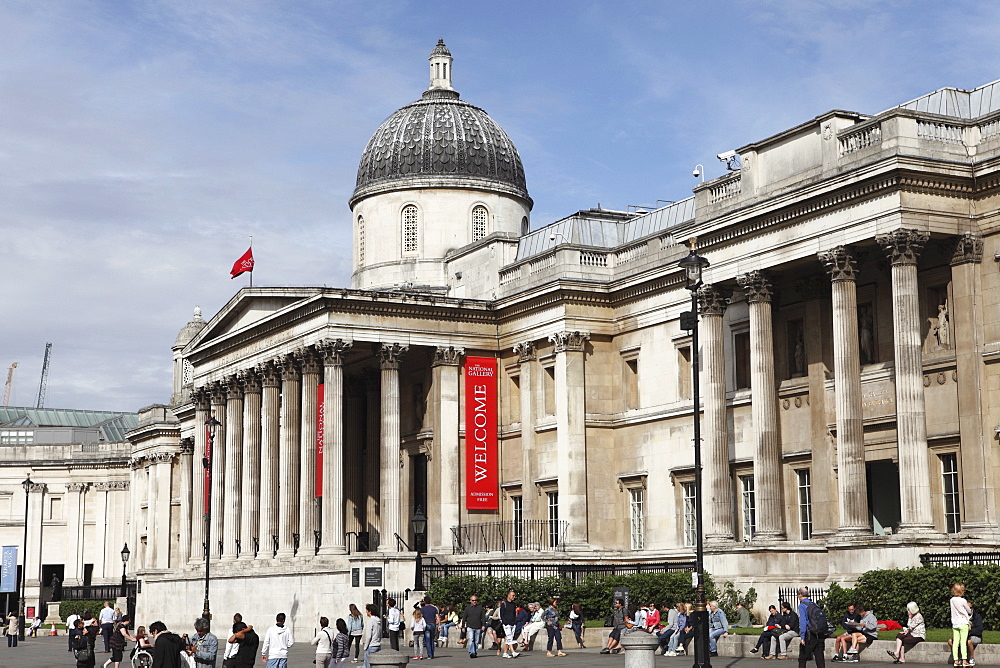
[813,246,871,534]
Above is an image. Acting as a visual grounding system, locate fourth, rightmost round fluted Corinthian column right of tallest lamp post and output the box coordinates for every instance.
[875,228,933,532]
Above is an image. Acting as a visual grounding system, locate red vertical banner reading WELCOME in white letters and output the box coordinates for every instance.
[465,357,500,510]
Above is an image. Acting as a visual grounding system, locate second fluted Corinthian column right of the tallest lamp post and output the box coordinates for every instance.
[737,271,785,540]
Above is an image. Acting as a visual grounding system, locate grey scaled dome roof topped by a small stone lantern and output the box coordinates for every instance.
[350,41,531,207]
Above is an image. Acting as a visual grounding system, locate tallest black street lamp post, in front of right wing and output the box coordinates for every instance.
[678,239,712,668]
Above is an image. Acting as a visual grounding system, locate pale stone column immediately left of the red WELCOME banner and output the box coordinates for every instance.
[434,346,465,552]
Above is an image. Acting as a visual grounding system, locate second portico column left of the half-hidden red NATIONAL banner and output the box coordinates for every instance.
[275,355,302,557]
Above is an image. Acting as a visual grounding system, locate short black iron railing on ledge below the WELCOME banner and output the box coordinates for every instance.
[451,520,569,554]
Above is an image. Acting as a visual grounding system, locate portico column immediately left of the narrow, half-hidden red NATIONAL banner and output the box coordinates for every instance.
[299,349,322,556]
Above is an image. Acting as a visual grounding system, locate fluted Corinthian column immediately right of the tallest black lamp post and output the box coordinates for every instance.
[695,285,735,541]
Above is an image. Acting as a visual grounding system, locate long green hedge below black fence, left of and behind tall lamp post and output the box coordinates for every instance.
[427,572,724,620]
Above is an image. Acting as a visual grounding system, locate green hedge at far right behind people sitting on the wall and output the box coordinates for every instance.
[823,566,1000,629]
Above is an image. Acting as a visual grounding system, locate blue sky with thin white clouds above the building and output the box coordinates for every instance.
[0,0,1000,411]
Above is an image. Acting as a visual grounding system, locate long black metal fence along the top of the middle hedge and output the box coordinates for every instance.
[419,561,694,587]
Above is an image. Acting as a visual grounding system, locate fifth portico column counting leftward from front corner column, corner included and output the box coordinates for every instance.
[239,369,262,559]
